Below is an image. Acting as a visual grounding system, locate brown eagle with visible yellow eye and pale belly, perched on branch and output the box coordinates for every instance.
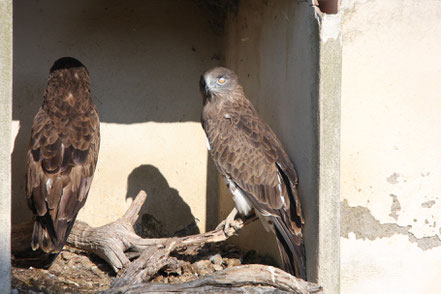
[200,67,306,280]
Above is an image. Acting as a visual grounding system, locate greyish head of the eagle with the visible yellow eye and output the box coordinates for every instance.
[199,67,240,103]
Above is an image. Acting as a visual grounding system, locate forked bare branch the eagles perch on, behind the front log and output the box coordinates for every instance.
[11,191,254,276]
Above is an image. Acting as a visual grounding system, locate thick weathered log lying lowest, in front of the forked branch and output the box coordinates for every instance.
[103,264,323,294]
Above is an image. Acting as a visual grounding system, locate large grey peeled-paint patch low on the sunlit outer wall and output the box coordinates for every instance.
[340,199,441,251]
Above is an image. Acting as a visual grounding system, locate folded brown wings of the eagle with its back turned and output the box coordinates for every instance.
[26,107,100,253]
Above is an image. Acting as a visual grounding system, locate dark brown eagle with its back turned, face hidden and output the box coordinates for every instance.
[26,57,100,266]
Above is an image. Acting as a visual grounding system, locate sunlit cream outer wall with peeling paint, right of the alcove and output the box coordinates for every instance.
[341,0,441,293]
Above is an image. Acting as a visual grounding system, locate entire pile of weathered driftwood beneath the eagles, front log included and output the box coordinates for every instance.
[11,191,320,293]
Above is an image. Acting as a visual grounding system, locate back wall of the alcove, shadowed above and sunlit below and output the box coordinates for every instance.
[12,0,222,234]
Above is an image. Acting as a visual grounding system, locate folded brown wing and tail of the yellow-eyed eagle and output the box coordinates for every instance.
[203,101,306,279]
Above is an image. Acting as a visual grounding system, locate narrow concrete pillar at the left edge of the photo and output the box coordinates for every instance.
[0,0,12,293]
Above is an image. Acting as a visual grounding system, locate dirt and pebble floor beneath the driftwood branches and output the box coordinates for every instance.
[11,243,273,294]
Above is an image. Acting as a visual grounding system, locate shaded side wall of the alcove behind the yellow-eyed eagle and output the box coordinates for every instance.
[223,0,319,281]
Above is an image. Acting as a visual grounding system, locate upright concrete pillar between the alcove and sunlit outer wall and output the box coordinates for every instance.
[317,13,342,293]
